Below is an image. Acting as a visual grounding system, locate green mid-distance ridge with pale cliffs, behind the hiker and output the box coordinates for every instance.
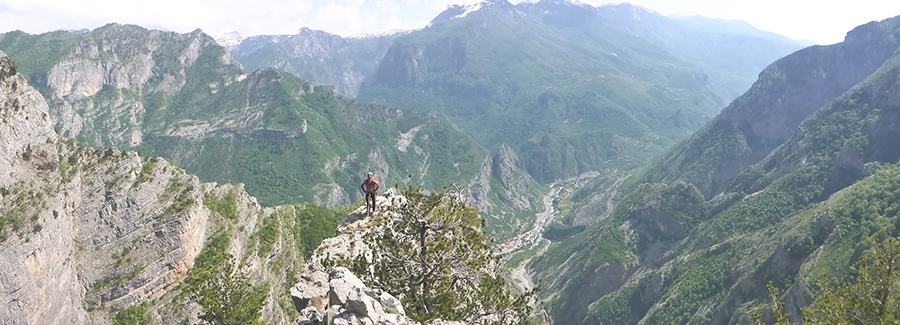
[0,24,543,236]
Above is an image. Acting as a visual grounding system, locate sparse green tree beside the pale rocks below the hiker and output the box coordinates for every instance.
[354,187,534,324]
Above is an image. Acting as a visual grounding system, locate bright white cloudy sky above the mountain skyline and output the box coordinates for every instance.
[0,0,900,44]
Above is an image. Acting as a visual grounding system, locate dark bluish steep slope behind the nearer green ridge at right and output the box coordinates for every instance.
[646,20,898,198]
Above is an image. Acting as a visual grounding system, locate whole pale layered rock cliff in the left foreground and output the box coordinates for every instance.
[0,52,301,324]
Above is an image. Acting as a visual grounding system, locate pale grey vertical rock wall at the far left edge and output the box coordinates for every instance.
[0,52,87,323]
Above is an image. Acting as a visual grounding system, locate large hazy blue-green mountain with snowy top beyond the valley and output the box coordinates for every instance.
[358,1,798,182]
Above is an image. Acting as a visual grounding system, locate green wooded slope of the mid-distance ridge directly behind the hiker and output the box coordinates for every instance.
[132,70,487,206]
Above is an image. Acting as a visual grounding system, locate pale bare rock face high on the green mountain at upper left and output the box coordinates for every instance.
[41,24,238,146]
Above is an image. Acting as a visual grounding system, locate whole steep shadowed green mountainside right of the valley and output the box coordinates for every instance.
[530,13,900,324]
